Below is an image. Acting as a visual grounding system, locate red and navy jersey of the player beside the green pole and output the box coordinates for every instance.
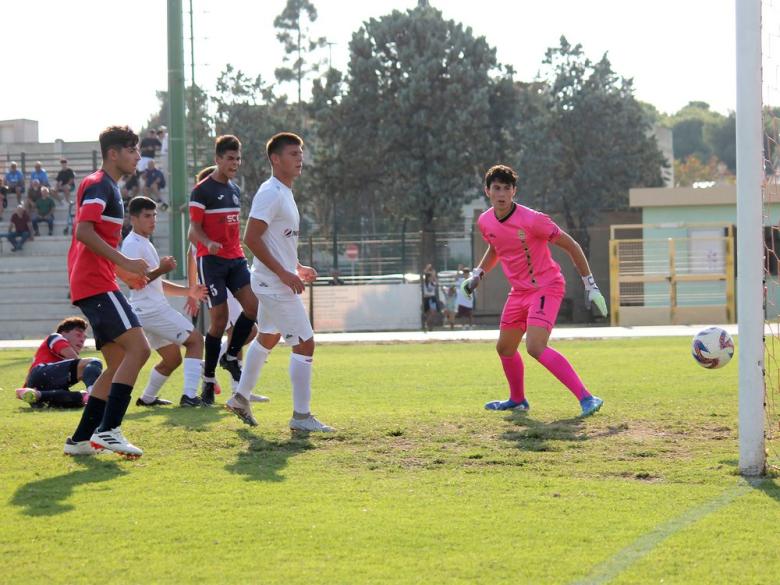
[190,176,244,258]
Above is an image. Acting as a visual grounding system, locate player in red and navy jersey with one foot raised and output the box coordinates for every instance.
[190,135,257,406]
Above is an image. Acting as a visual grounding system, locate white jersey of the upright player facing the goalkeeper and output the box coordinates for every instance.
[249,177,301,295]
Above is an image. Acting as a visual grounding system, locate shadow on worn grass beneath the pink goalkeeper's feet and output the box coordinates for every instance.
[501,412,628,451]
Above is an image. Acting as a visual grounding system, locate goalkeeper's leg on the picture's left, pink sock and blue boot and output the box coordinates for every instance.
[485,292,529,410]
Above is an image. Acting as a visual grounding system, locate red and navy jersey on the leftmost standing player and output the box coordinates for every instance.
[68,169,124,302]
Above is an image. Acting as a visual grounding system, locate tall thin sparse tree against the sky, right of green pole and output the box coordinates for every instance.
[274,0,327,125]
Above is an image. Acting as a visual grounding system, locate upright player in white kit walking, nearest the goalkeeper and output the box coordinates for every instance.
[225,132,334,432]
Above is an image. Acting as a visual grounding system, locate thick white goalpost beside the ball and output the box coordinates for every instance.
[736,0,766,476]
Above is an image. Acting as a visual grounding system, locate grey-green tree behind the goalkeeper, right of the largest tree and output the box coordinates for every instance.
[518,37,665,255]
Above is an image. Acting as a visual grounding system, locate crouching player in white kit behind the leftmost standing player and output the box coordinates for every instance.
[122,196,207,406]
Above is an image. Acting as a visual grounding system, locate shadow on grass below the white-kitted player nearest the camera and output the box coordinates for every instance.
[225,429,315,481]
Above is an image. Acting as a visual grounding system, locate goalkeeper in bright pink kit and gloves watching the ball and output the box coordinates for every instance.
[461,165,607,416]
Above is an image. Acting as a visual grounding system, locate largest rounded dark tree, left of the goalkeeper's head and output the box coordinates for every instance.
[339,3,508,263]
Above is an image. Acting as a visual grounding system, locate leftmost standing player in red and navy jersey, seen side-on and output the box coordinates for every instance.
[65,126,156,458]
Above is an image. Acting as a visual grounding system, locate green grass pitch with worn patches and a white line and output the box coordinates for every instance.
[0,339,780,585]
